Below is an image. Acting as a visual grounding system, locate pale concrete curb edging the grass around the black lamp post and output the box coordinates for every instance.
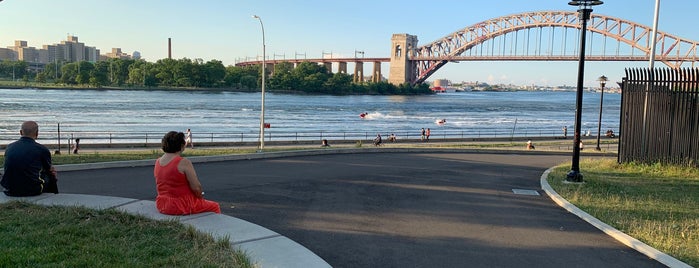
[541,168,692,268]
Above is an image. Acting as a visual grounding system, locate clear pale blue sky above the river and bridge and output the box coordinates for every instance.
[0,0,699,86]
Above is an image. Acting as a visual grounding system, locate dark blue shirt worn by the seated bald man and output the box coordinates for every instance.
[0,137,51,196]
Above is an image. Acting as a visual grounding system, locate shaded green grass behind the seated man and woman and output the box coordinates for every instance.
[0,201,253,267]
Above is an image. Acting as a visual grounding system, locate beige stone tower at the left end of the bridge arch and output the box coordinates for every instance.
[388,34,417,85]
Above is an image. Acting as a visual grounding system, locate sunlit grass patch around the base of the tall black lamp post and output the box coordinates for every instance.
[548,159,699,267]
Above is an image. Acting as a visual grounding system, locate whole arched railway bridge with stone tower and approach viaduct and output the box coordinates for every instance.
[236,11,699,85]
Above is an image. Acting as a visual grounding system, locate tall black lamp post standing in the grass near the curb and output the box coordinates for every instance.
[566,0,603,182]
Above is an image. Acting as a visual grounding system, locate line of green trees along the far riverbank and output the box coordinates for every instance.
[0,58,431,95]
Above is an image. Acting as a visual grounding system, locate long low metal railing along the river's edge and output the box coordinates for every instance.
[0,128,618,148]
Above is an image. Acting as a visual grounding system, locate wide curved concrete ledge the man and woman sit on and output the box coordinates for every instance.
[0,194,331,268]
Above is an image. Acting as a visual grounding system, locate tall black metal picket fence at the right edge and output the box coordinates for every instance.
[618,68,699,166]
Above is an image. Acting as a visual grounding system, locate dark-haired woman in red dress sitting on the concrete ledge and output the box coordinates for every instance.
[153,131,221,215]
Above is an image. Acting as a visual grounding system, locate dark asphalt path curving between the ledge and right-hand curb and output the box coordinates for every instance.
[59,152,664,267]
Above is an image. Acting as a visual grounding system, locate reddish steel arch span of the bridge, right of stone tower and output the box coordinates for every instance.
[406,11,699,84]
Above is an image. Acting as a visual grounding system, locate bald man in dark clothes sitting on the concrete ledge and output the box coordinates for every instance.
[0,121,58,196]
